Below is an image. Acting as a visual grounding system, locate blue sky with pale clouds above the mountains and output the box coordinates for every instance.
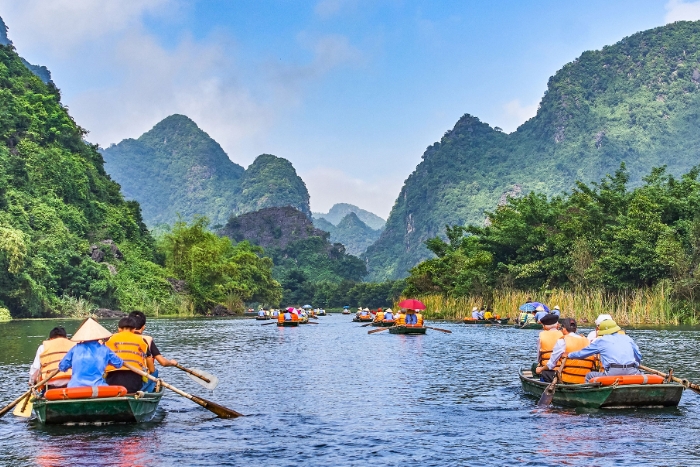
[0,0,700,218]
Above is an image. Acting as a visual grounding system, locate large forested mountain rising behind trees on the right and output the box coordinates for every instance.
[364,22,700,280]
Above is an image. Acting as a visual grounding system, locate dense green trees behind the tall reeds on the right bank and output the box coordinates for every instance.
[406,164,700,318]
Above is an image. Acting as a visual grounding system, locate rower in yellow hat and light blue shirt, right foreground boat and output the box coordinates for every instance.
[565,319,642,382]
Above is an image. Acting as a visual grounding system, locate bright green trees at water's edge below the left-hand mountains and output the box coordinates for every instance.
[159,217,281,312]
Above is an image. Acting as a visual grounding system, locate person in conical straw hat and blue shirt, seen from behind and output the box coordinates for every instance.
[58,318,124,388]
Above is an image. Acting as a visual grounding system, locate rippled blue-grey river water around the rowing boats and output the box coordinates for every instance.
[0,315,700,467]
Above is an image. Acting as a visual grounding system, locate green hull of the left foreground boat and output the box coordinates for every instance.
[33,388,163,425]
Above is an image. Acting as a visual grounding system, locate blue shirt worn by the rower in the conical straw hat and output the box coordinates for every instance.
[58,341,124,388]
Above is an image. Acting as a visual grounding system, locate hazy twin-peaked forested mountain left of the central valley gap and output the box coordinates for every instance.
[101,115,311,226]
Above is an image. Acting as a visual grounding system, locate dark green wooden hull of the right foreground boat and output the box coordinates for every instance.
[519,368,683,409]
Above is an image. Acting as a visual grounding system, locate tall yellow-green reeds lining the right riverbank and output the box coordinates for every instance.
[420,285,680,325]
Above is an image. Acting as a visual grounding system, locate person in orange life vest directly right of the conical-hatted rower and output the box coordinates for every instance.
[105,316,155,394]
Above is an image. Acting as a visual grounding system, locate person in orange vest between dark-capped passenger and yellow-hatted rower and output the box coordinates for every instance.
[538,318,596,384]
